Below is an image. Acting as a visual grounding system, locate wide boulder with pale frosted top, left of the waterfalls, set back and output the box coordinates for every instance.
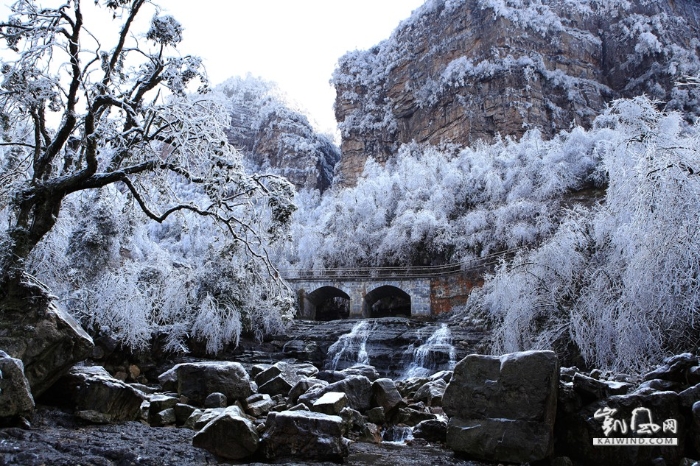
[158,361,252,406]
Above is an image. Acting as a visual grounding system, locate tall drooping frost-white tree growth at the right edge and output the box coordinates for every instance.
[478,98,700,371]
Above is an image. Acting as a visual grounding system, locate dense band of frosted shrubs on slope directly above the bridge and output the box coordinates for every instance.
[288,124,612,268]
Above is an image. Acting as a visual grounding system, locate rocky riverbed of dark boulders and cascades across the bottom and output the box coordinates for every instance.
[0,318,700,466]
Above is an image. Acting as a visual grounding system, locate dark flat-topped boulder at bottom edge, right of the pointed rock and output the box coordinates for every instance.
[261,411,348,461]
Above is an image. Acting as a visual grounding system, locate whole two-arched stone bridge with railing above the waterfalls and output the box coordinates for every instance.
[281,250,513,320]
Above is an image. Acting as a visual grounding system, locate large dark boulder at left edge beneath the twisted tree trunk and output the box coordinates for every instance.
[0,277,94,398]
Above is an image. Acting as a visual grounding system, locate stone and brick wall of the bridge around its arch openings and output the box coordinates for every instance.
[288,273,483,320]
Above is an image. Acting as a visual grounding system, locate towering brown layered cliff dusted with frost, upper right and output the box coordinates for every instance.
[333,0,700,185]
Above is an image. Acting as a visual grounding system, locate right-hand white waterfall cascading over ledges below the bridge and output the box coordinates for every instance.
[403,324,456,379]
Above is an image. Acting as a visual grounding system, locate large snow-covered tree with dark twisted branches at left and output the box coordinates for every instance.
[0,0,294,349]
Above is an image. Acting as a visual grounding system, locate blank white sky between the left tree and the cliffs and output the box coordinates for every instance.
[160,0,424,137]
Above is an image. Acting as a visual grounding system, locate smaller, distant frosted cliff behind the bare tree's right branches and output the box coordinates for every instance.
[218,76,340,191]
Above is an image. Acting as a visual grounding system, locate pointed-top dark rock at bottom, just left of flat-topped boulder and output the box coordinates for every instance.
[192,410,259,460]
